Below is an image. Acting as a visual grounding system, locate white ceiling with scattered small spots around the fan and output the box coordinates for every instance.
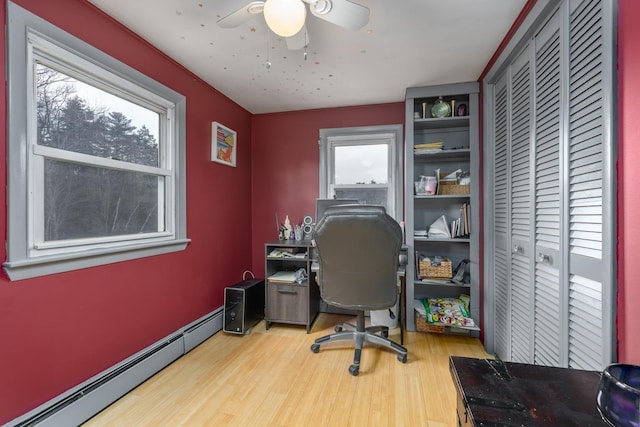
[89,0,526,114]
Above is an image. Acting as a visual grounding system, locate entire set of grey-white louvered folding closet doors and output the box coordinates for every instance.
[485,0,615,370]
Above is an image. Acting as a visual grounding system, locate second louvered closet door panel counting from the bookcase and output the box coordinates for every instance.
[509,46,534,363]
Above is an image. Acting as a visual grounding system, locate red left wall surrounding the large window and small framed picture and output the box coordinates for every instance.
[0,0,251,424]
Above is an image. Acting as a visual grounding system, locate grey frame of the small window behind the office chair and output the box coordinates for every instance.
[319,125,403,222]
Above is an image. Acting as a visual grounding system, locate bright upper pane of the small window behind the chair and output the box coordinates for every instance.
[334,144,389,185]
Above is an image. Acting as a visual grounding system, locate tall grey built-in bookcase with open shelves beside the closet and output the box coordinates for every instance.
[404,82,480,334]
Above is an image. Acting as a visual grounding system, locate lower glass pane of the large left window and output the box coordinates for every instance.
[44,160,164,241]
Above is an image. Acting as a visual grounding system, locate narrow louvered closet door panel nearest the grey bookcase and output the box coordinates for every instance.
[493,76,511,360]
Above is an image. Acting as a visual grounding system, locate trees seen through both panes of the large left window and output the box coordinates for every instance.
[36,64,165,241]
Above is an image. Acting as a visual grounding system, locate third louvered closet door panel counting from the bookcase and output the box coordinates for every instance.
[533,13,564,366]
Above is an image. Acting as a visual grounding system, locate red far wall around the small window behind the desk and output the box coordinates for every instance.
[251,102,404,277]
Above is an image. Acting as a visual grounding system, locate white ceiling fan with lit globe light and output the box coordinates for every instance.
[218,0,369,50]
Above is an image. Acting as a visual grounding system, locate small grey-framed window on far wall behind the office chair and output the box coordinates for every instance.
[320,125,402,221]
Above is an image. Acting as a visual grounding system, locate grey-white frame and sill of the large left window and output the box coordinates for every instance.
[3,2,189,280]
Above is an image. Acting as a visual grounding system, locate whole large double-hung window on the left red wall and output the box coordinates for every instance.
[4,4,187,279]
